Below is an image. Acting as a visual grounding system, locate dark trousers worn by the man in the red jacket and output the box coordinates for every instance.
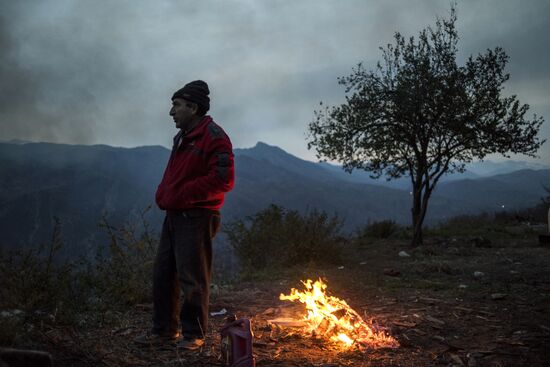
[153,209,220,337]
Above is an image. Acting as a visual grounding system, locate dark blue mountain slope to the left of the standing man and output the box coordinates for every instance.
[0,143,169,255]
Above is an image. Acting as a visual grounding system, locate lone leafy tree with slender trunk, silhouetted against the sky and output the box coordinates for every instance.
[308,7,544,244]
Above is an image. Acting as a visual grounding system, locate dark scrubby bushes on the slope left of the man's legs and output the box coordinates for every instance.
[0,210,157,336]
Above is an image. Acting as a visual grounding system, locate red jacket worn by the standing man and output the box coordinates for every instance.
[155,116,235,210]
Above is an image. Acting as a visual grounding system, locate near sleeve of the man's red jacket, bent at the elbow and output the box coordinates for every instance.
[164,136,235,207]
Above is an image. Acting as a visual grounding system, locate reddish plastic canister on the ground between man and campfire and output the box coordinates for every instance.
[221,316,256,367]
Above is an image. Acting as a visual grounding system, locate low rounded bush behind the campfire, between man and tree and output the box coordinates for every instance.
[224,205,345,273]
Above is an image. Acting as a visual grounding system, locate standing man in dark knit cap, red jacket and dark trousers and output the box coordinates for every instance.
[135,80,235,349]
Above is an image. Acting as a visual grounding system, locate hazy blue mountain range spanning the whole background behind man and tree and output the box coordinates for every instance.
[0,143,550,256]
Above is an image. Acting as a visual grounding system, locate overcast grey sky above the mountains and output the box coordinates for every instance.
[0,0,550,163]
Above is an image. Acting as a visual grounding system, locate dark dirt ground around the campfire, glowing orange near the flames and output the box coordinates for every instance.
[8,235,550,367]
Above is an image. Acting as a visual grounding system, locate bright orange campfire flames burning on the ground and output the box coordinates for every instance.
[279,279,399,349]
